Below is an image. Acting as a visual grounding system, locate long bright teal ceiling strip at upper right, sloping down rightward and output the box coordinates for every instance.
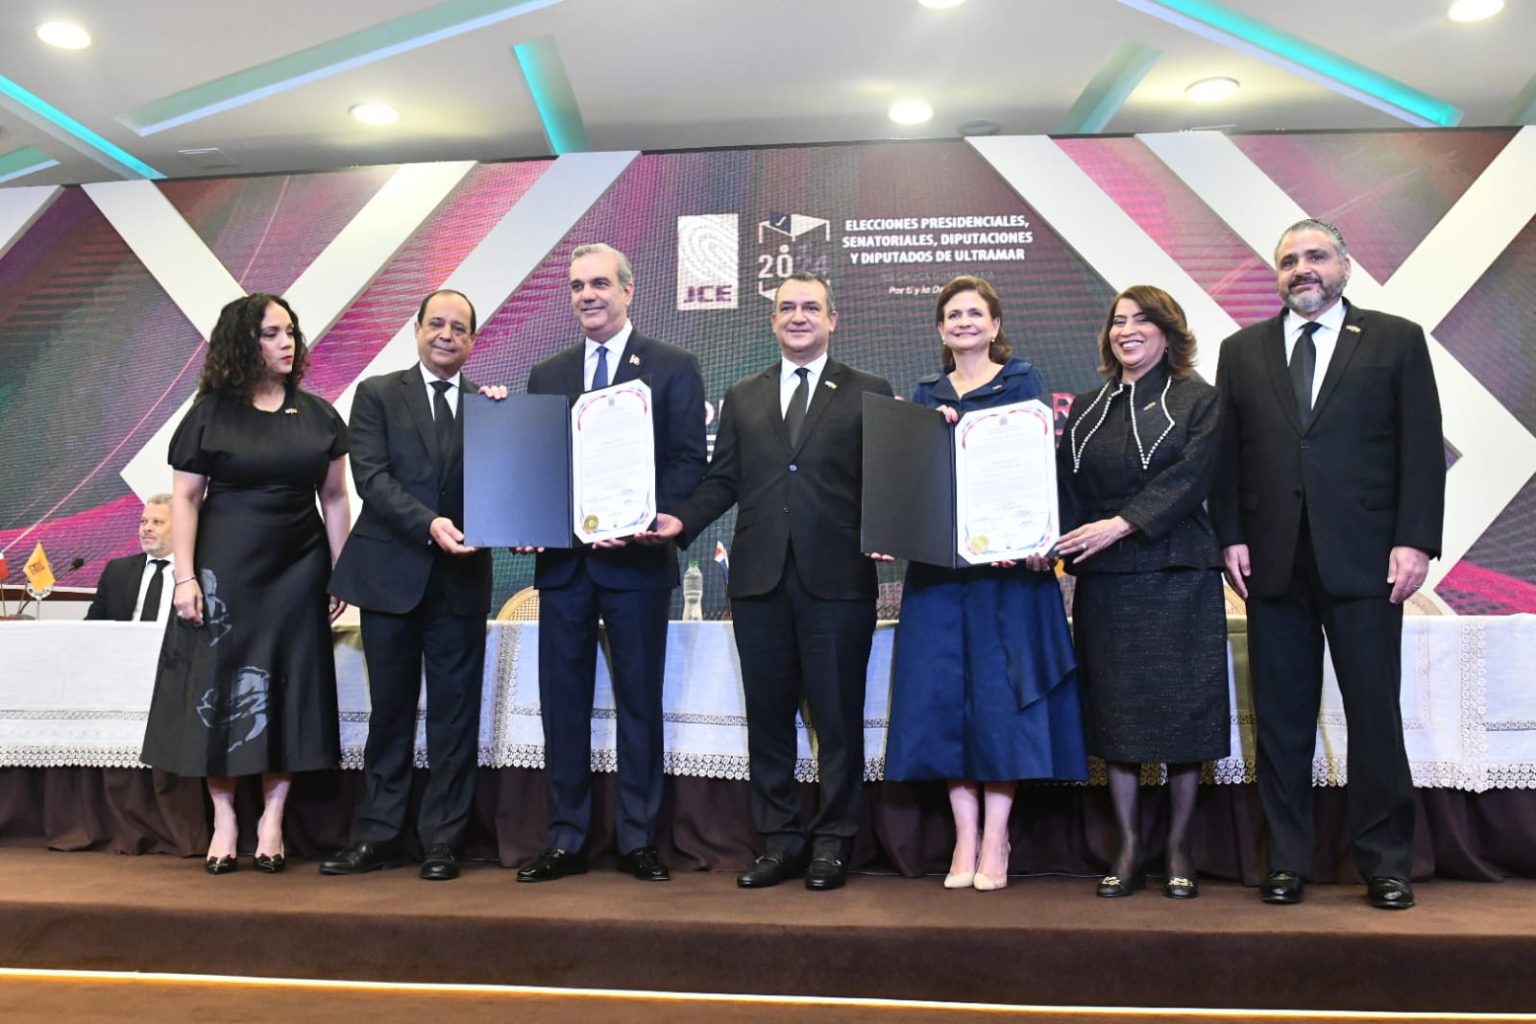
[1120,0,1462,127]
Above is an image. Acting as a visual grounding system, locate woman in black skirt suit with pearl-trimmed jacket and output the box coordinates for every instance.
[1057,284,1230,900]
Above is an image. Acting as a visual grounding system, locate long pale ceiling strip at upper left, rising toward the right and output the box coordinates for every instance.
[118,0,562,135]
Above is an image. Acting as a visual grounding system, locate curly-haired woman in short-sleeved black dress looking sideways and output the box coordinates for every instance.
[140,295,350,875]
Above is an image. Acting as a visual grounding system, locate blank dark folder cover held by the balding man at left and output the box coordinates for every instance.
[459,395,573,548]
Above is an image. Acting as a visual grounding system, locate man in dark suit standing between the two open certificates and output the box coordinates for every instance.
[647,272,891,889]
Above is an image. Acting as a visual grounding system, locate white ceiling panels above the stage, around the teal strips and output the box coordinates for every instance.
[0,0,1536,184]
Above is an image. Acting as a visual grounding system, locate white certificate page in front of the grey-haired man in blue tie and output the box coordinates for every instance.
[571,381,656,543]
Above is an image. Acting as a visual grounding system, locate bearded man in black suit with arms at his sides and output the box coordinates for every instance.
[1210,220,1445,909]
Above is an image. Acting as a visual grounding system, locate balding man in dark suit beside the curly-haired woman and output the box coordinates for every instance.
[319,290,505,881]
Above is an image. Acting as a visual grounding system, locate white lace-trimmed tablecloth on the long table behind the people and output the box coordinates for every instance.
[0,616,1536,792]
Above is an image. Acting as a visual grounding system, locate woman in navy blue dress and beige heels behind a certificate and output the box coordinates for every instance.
[885,276,1087,890]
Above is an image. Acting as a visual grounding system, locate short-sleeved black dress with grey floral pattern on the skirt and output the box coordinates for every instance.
[140,388,347,777]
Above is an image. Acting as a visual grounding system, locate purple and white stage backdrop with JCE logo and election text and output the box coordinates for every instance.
[0,127,1536,614]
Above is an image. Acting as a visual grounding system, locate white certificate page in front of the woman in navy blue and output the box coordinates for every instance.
[954,401,1060,565]
